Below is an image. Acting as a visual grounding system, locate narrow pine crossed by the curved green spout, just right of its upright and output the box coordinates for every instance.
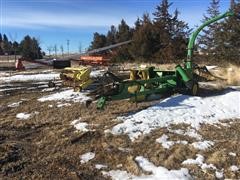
[199,0,221,59]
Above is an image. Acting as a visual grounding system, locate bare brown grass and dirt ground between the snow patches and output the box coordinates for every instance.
[0,65,240,180]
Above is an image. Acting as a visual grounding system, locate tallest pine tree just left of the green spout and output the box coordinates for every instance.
[153,0,190,63]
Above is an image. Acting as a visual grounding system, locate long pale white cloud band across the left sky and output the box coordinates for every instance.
[2,11,135,28]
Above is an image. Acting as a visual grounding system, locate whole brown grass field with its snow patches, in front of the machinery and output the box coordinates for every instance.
[0,61,240,180]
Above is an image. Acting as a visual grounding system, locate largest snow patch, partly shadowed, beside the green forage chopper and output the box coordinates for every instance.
[111,90,240,140]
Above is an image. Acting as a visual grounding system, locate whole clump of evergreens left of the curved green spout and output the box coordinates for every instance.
[87,0,190,63]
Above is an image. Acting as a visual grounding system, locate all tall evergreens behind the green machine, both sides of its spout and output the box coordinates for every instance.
[89,0,240,63]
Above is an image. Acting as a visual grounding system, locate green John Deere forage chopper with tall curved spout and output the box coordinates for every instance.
[94,11,234,109]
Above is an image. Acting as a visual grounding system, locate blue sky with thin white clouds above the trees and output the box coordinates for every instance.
[0,0,230,52]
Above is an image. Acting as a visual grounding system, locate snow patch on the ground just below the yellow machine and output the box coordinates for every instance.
[38,89,91,103]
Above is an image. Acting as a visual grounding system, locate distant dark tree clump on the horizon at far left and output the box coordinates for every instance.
[0,33,44,60]
